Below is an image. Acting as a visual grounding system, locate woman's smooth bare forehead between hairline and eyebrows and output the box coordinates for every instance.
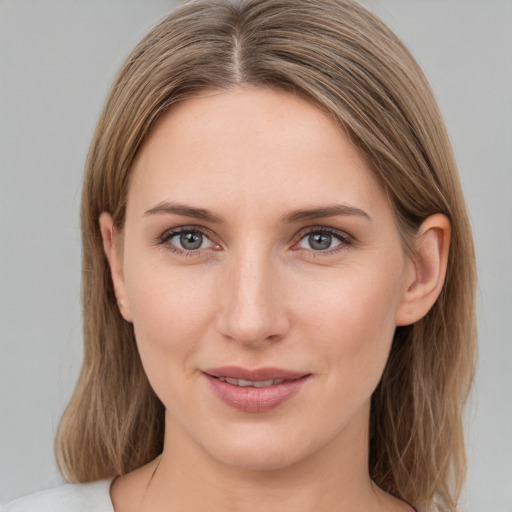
[128,87,383,219]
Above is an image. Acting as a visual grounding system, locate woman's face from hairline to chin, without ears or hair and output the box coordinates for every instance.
[102,87,412,469]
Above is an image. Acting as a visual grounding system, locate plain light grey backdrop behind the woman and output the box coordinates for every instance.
[0,0,512,512]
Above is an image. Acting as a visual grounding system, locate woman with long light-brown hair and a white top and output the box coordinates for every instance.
[3,0,475,512]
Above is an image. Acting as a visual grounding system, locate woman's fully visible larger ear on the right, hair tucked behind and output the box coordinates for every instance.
[396,213,451,325]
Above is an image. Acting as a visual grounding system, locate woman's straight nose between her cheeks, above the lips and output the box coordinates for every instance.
[218,251,290,348]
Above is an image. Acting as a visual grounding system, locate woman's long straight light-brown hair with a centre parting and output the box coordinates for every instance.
[56,0,476,511]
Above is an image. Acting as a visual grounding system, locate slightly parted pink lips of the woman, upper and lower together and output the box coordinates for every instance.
[203,366,311,413]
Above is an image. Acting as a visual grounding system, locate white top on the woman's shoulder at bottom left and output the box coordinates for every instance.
[0,480,114,512]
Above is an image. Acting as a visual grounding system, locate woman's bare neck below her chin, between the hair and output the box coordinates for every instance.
[142,408,378,512]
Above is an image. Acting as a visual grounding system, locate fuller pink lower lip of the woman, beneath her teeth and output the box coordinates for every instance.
[204,374,310,412]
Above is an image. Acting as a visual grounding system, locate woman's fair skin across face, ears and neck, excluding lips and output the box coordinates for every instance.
[100,87,449,512]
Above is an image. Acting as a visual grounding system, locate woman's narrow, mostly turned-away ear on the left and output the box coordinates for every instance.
[99,212,132,322]
